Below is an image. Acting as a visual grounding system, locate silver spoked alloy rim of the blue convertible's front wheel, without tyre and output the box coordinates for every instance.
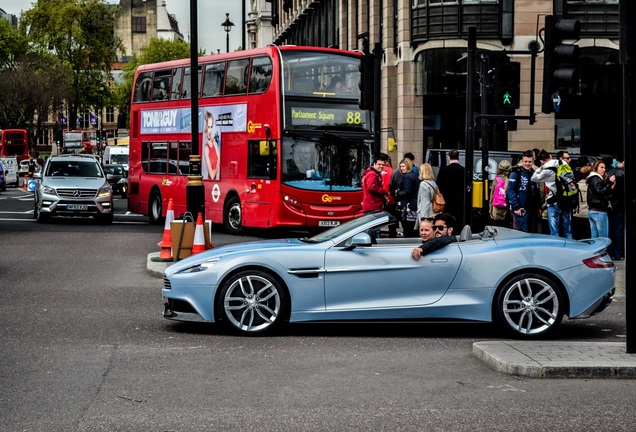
[223,272,282,333]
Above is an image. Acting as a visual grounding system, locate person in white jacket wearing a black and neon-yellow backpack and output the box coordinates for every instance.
[532,150,579,238]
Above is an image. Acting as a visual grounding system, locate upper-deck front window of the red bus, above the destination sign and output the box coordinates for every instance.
[281,51,360,100]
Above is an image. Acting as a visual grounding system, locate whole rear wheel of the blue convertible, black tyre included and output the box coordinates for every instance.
[494,273,565,339]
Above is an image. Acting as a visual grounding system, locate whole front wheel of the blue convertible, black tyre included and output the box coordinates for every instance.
[217,270,288,336]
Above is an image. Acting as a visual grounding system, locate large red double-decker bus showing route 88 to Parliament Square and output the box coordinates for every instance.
[128,46,373,233]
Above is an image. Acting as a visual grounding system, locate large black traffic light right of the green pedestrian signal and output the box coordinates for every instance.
[541,15,581,114]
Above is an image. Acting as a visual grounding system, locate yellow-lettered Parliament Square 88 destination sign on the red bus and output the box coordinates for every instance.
[290,107,367,129]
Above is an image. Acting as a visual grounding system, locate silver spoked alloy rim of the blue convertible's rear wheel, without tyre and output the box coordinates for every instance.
[499,275,563,336]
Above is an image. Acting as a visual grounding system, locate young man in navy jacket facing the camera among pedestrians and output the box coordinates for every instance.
[506,151,540,232]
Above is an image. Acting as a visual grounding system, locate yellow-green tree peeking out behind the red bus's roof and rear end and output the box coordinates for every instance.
[115,38,191,128]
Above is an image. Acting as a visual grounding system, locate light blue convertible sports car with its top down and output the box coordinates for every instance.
[163,212,615,338]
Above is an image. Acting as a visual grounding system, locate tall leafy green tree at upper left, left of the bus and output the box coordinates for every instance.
[21,0,123,128]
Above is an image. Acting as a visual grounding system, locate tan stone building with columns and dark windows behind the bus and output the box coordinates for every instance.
[248,0,623,163]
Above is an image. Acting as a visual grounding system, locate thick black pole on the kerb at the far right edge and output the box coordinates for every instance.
[619,0,636,354]
